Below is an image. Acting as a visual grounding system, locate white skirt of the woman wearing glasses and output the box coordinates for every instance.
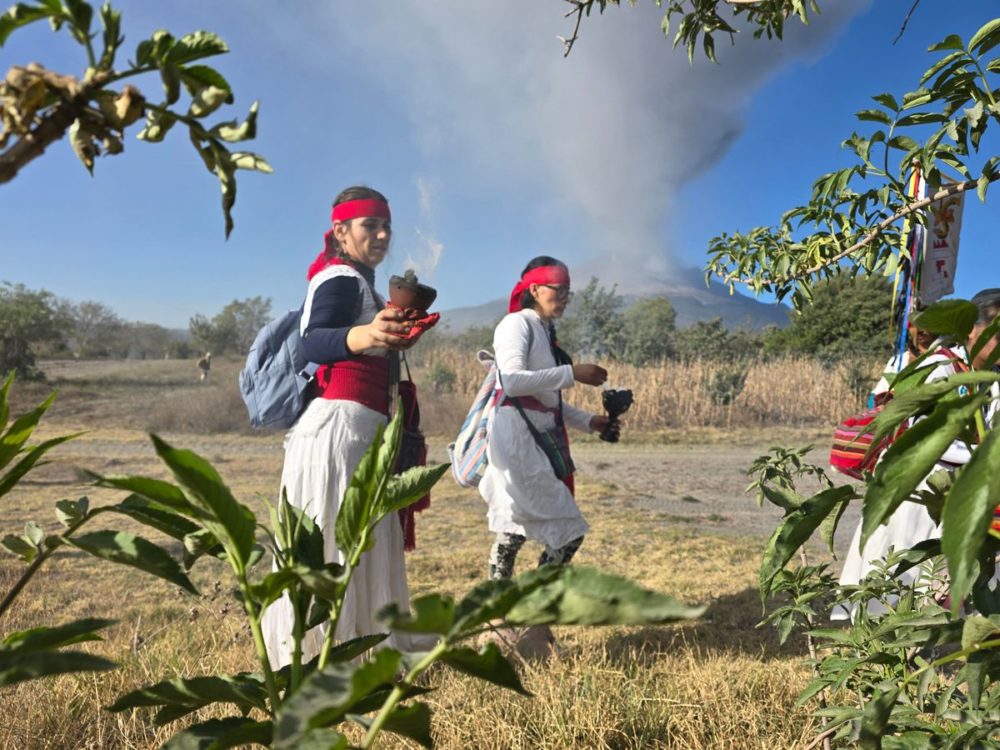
[479,406,588,549]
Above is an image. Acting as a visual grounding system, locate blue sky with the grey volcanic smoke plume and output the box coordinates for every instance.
[0,0,1000,327]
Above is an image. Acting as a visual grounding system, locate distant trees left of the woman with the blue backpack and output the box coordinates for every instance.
[0,281,271,378]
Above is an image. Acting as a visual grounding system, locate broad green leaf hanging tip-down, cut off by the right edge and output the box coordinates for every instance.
[941,430,1000,612]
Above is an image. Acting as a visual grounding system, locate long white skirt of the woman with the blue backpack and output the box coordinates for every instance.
[263,398,417,669]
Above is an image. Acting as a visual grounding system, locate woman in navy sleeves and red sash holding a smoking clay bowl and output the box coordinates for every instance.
[264,187,420,667]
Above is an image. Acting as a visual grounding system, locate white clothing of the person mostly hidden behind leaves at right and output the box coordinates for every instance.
[831,346,1000,620]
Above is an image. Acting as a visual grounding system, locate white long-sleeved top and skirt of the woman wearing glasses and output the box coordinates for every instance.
[479,309,593,549]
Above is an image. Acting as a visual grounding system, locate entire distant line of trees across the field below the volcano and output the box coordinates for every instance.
[0,276,892,377]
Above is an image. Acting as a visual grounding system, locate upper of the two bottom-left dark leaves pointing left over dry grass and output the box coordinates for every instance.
[107,674,267,725]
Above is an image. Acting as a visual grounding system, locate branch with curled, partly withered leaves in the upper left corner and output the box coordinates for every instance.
[0,0,271,237]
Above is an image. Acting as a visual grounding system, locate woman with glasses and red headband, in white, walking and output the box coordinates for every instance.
[479,256,609,579]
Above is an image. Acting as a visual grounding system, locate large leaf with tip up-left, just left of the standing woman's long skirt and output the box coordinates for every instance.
[151,435,257,568]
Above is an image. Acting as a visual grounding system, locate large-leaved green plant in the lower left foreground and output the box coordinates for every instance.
[0,379,701,750]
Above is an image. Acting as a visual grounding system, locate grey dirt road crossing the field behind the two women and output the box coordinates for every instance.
[34,430,860,556]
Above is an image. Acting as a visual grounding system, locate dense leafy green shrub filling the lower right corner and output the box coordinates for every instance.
[748,300,1000,748]
